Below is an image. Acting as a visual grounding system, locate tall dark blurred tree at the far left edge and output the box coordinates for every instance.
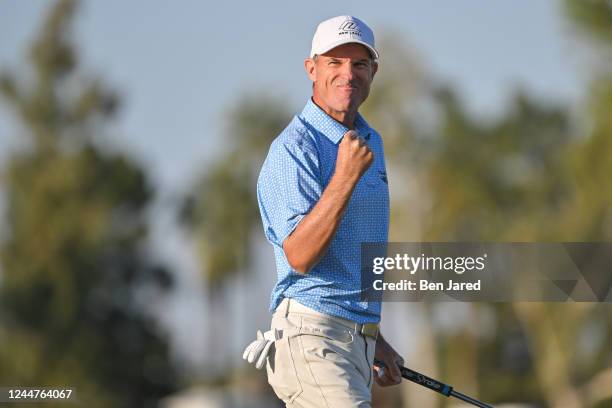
[0,1,177,407]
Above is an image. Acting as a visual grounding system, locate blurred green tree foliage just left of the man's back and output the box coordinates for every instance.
[181,95,290,292]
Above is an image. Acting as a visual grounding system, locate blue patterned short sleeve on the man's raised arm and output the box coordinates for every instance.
[257,140,322,248]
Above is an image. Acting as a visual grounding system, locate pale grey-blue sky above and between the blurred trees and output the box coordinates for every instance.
[0,0,586,372]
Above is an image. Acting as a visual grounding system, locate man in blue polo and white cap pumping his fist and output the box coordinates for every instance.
[253,16,403,408]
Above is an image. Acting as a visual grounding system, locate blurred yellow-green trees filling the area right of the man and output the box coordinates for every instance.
[358,33,612,406]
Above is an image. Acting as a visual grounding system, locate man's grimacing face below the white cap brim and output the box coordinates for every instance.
[305,43,378,117]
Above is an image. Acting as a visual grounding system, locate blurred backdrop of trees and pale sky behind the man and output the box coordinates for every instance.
[0,0,612,408]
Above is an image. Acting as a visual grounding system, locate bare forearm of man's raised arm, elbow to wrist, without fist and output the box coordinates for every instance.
[283,175,358,274]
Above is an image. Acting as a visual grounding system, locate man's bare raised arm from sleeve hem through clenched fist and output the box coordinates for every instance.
[283,130,374,274]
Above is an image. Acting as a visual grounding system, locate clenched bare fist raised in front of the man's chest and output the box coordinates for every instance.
[335,130,374,183]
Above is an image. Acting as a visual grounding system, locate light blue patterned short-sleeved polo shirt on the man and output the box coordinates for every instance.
[257,99,389,324]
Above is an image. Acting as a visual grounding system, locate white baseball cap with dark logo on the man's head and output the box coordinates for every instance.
[310,16,378,59]
